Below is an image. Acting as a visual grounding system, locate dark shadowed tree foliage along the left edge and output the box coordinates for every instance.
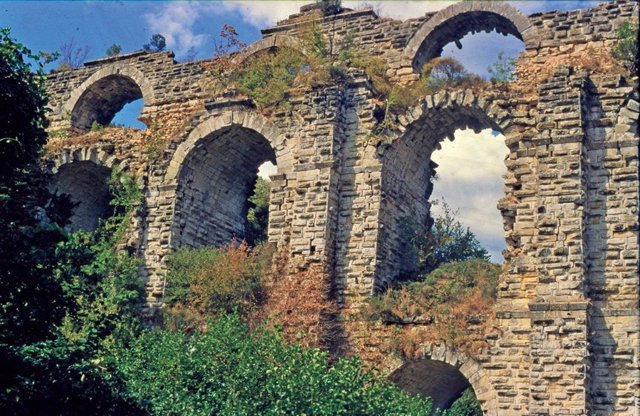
[0,25,64,352]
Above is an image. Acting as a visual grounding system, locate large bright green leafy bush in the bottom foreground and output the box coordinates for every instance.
[116,316,431,416]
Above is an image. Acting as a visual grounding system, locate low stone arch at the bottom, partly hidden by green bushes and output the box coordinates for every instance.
[388,343,497,416]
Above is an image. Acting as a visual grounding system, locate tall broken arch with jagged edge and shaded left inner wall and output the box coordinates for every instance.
[374,89,516,290]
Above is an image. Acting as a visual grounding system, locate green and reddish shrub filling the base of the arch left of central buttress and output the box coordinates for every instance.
[165,243,270,316]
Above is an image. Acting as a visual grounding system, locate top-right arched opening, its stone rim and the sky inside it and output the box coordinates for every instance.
[405,2,531,75]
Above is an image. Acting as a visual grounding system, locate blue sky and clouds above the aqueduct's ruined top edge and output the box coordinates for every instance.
[0,1,597,69]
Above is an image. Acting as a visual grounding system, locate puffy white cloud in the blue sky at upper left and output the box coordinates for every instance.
[144,2,214,55]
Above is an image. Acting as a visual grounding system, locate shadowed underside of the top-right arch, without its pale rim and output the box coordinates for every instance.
[413,11,522,71]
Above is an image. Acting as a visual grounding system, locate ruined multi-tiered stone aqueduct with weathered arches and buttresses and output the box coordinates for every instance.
[42,0,640,415]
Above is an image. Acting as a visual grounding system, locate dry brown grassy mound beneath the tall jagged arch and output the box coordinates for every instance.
[362,260,499,358]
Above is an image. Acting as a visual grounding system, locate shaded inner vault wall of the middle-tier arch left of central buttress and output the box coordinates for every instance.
[173,127,275,247]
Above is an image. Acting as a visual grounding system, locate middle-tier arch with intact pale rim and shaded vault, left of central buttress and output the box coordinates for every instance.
[165,110,286,247]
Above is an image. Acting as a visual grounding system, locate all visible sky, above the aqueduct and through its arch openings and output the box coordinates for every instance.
[0,0,599,261]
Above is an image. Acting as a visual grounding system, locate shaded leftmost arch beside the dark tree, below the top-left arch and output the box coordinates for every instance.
[48,147,126,231]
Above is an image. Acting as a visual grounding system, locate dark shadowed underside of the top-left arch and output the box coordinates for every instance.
[71,75,142,132]
